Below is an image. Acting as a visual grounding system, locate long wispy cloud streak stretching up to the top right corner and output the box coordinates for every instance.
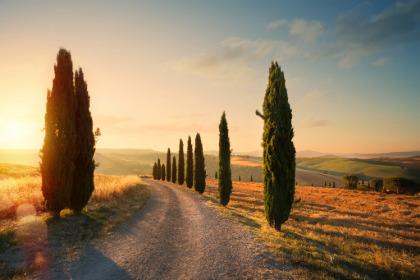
[175,0,420,76]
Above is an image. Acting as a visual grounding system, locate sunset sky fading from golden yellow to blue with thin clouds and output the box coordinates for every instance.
[0,0,420,153]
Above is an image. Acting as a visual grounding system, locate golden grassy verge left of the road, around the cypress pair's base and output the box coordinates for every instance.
[0,175,150,279]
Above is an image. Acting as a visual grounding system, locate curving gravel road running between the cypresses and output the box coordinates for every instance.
[37,180,285,280]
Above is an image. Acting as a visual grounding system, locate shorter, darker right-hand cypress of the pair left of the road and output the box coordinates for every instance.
[70,68,95,212]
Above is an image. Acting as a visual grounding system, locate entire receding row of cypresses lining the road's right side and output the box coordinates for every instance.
[153,61,296,230]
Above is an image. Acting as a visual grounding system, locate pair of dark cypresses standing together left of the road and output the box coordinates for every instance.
[40,49,99,216]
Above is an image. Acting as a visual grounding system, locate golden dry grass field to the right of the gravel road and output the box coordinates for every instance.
[205,180,420,279]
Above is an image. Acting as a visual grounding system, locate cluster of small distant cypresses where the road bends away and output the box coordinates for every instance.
[153,133,206,193]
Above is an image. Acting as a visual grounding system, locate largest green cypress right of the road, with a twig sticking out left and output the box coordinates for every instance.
[256,62,296,230]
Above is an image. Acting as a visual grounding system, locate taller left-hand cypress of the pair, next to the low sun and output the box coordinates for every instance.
[40,49,78,215]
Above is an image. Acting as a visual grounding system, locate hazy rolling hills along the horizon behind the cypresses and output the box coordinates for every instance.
[0,149,420,186]
